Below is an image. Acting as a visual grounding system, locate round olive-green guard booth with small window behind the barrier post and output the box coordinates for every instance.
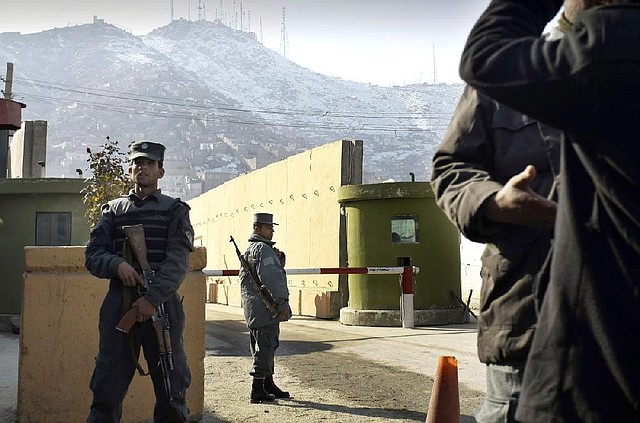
[338,182,468,326]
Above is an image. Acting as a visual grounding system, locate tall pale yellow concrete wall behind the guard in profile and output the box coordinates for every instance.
[189,141,362,318]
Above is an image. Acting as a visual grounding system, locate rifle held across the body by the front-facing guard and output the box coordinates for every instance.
[116,225,173,403]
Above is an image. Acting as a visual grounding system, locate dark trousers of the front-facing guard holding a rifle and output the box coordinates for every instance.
[87,289,191,423]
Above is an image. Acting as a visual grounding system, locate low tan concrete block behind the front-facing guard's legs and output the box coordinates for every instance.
[18,247,206,423]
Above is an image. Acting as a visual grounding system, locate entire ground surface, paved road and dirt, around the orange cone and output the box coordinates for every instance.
[0,304,484,423]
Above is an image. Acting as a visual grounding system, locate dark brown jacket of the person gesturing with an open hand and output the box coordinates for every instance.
[432,87,561,364]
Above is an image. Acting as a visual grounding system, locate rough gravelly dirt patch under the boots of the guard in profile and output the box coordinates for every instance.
[201,354,484,423]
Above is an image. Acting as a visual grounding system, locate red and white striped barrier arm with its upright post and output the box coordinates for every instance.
[202,266,420,328]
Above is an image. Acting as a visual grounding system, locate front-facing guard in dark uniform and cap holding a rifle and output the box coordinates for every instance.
[85,141,193,423]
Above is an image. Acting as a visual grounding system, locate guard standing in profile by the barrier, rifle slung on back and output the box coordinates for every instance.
[240,213,291,403]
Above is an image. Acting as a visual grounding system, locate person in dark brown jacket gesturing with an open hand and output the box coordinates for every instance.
[431,86,561,423]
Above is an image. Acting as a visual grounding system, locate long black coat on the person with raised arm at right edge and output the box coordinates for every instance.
[460,0,640,422]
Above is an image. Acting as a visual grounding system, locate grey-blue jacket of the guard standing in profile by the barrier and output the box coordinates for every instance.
[240,234,289,329]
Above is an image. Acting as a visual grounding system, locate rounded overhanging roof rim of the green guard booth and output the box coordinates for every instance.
[338,182,434,203]
